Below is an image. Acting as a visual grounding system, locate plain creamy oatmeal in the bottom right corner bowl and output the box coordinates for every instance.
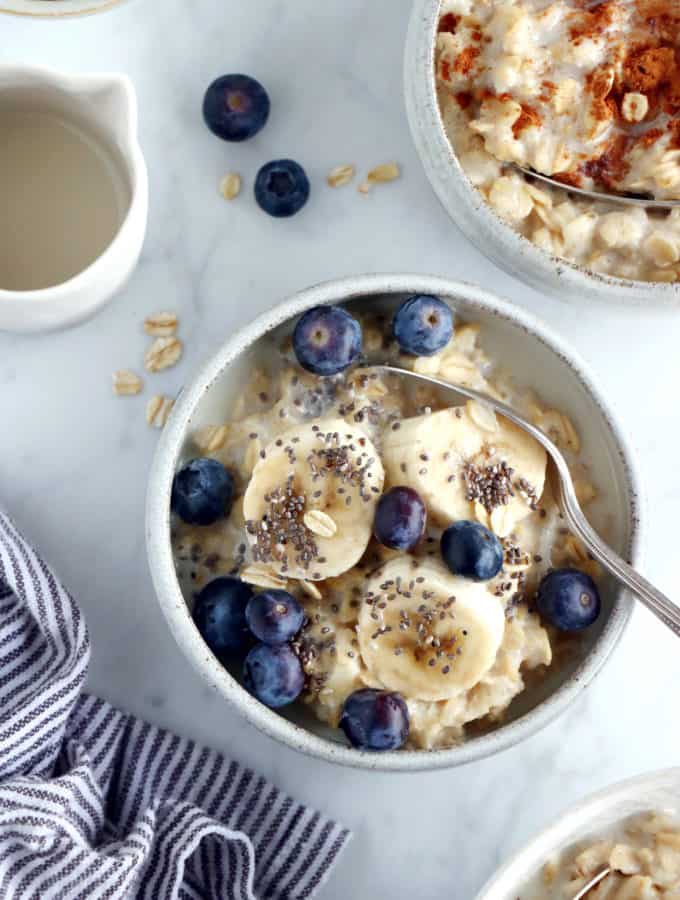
[521,812,680,900]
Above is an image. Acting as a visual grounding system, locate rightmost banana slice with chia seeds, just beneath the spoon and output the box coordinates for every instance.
[383,402,546,537]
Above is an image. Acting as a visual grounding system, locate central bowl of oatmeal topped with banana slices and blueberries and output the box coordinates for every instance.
[147,275,640,770]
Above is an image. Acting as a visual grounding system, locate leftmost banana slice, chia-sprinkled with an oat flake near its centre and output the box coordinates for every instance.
[243,419,385,581]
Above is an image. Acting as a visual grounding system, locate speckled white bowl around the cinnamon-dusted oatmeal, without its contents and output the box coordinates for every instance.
[404,0,680,303]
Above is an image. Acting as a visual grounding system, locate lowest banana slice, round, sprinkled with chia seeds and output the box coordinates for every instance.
[357,556,505,700]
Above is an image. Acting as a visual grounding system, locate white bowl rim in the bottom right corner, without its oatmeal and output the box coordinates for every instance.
[475,768,680,900]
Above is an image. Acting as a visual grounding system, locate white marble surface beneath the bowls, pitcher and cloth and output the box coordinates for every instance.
[0,0,680,900]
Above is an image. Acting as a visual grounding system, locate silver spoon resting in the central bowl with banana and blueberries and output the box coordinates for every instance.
[371,365,680,637]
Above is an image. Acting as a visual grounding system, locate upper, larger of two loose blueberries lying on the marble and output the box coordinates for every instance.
[203,75,270,141]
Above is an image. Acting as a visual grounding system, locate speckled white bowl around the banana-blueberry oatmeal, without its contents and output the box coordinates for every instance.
[147,275,640,770]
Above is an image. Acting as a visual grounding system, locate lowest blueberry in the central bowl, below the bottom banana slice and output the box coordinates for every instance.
[340,688,409,750]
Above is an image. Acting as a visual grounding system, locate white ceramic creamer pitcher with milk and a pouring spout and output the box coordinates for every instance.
[0,65,149,332]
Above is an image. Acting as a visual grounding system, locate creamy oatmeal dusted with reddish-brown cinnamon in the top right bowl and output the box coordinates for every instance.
[436,0,680,282]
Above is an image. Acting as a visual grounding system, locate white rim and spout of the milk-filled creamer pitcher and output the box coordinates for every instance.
[0,64,149,307]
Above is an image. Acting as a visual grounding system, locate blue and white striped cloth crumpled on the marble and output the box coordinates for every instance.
[0,513,349,900]
